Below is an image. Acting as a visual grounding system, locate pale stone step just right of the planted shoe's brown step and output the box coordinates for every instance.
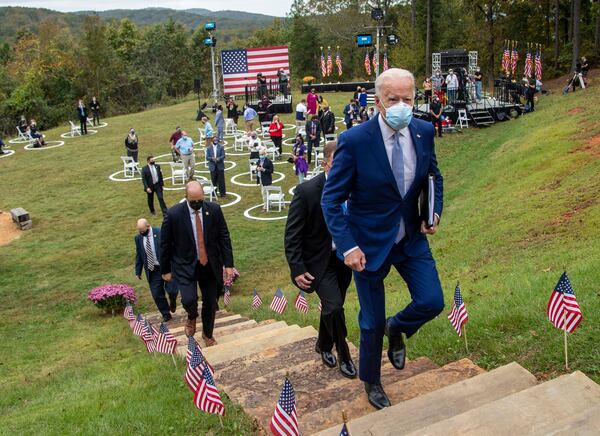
[319,362,537,436]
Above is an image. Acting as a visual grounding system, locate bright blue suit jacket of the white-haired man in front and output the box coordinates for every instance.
[321,116,443,271]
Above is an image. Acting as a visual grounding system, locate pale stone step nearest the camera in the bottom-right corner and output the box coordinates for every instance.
[409,371,600,436]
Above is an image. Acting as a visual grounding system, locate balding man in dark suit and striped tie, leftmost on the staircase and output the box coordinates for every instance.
[133,218,177,322]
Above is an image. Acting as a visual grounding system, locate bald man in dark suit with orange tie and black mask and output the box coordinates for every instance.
[161,180,233,346]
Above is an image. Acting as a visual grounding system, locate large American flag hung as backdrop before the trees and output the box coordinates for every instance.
[221,46,290,95]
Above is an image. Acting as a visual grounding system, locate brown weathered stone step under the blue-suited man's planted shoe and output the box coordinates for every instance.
[300,357,484,434]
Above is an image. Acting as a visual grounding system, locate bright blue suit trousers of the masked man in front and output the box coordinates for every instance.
[354,241,444,383]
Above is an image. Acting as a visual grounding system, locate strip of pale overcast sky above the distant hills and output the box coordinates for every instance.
[0,0,292,17]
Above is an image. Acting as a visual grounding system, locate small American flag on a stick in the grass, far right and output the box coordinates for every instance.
[546,272,583,333]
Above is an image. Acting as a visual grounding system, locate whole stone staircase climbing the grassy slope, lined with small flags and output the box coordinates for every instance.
[146,309,600,436]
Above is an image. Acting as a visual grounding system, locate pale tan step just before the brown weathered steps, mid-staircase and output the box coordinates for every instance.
[204,326,317,365]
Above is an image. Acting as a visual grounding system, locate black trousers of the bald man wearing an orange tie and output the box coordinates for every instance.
[177,262,217,338]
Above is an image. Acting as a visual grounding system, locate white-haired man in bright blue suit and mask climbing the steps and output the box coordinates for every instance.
[321,68,444,408]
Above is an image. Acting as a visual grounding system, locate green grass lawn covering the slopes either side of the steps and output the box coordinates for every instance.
[0,88,600,434]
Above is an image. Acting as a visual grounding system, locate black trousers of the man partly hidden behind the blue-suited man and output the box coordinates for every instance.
[316,251,352,362]
